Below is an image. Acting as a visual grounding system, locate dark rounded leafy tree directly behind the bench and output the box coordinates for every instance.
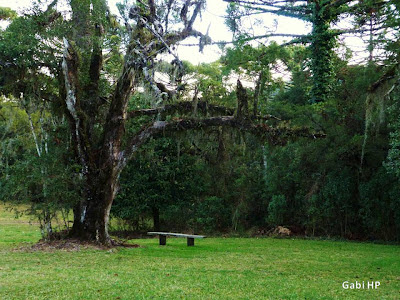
[111,137,208,231]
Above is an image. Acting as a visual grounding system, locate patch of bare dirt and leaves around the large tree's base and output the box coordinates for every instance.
[14,239,140,252]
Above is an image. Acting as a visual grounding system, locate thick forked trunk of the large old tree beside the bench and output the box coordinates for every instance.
[63,32,134,245]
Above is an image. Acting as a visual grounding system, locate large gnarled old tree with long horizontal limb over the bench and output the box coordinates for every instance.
[62,0,223,244]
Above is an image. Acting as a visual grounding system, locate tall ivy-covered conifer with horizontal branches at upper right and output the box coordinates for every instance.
[224,0,364,103]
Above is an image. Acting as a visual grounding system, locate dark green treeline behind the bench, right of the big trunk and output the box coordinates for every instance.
[112,59,400,240]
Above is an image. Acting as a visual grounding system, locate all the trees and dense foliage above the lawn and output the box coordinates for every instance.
[0,0,400,242]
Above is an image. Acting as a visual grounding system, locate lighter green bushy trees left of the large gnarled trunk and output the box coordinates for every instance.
[0,99,80,239]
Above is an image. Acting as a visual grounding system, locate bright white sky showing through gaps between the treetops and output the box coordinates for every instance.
[0,0,365,64]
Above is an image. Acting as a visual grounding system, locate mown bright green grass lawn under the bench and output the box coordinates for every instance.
[0,206,400,300]
